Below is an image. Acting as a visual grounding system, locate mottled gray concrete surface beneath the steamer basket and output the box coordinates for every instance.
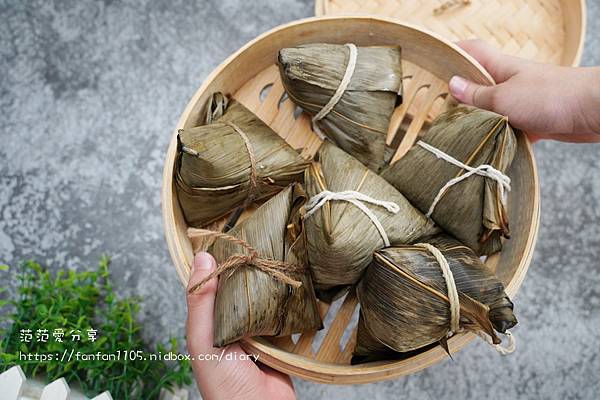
[0,0,600,399]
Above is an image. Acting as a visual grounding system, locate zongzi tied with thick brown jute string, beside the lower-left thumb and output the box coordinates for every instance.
[190,184,322,347]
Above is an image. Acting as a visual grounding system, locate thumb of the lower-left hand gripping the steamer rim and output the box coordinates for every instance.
[187,252,217,353]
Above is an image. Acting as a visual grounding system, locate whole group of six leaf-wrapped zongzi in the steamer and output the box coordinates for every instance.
[175,39,517,363]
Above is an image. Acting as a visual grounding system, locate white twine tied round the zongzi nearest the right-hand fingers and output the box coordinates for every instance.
[417,140,510,217]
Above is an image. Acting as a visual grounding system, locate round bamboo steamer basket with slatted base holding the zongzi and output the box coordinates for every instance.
[162,17,540,384]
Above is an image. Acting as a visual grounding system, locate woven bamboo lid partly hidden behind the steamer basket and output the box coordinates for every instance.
[315,0,586,66]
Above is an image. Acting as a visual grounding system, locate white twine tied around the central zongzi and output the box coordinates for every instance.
[304,190,400,247]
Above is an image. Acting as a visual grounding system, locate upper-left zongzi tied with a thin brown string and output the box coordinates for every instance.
[175,93,308,227]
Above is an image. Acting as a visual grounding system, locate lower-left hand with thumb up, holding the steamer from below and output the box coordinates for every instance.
[187,252,296,400]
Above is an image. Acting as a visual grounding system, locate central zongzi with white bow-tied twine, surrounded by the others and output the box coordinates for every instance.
[304,142,438,300]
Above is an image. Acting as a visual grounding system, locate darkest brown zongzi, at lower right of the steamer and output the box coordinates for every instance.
[354,234,517,358]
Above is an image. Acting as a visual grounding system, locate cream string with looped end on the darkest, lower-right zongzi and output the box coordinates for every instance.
[415,243,517,356]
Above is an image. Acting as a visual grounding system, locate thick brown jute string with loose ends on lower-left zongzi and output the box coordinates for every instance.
[188,228,306,293]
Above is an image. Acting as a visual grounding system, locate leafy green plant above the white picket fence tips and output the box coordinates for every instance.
[0,257,191,399]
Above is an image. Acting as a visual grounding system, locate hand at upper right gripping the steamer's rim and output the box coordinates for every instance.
[449,40,600,142]
